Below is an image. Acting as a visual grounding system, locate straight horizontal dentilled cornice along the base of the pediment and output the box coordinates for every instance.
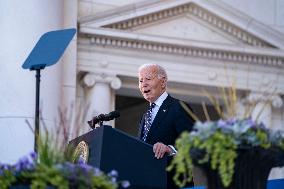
[79,27,284,67]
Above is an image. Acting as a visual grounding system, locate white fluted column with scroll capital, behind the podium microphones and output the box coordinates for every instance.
[83,73,121,126]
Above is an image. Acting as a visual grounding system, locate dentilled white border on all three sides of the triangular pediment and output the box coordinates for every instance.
[79,0,284,67]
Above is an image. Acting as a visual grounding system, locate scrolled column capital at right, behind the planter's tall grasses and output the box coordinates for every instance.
[246,92,283,108]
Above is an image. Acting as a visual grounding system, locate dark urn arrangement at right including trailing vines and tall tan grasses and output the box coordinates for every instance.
[167,79,284,189]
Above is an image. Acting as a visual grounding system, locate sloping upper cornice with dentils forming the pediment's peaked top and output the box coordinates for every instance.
[79,0,284,49]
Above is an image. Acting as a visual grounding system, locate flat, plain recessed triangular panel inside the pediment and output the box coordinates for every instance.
[131,14,240,45]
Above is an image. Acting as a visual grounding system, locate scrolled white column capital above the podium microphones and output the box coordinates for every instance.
[82,73,121,90]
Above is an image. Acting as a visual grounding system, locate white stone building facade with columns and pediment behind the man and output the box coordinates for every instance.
[0,0,284,178]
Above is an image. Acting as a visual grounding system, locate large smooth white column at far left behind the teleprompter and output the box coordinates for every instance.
[0,0,63,163]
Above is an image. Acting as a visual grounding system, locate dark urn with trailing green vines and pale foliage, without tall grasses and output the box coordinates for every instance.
[169,119,284,189]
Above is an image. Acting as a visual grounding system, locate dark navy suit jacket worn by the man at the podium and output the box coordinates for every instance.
[139,95,194,145]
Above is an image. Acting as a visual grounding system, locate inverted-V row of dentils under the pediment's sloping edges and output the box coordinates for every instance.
[103,3,274,47]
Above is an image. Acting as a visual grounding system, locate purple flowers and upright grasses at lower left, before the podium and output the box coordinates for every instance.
[0,106,130,189]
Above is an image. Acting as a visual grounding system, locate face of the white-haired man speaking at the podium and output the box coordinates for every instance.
[139,66,166,103]
